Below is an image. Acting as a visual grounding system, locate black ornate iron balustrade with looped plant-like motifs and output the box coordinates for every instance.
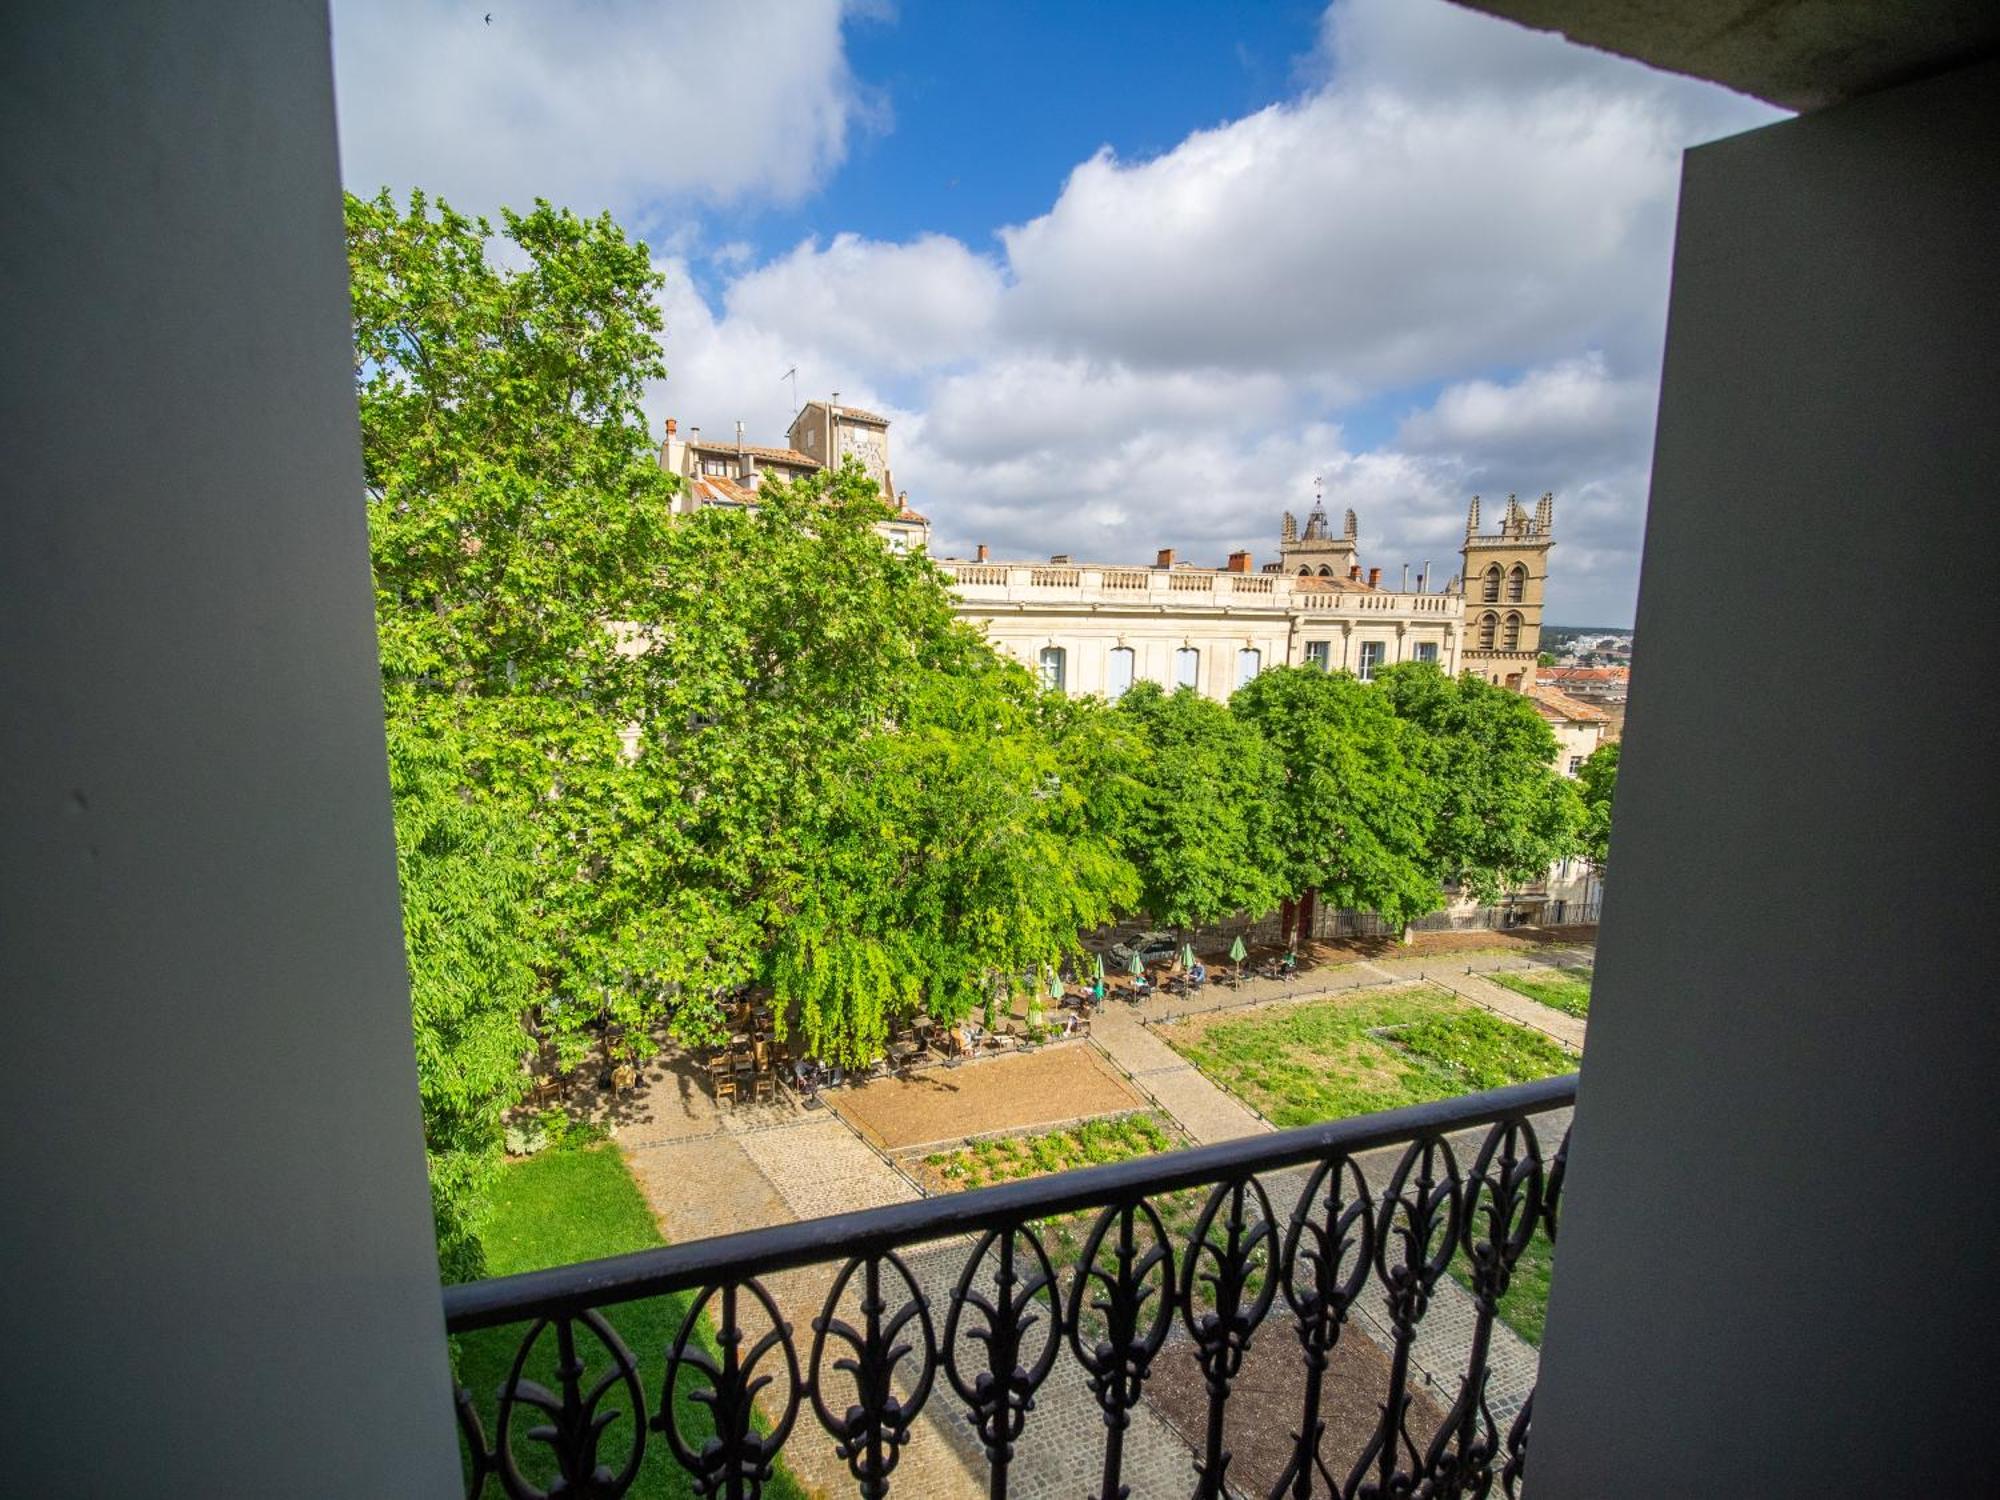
[444,1074,1576,1500]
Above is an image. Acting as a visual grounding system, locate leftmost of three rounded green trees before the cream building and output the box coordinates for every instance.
[1112,682,1292,928]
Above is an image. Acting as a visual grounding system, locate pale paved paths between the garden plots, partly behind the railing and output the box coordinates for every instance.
[614,952,1588,1500]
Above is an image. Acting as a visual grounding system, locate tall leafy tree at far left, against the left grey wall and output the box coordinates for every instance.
[346,194,672,1276]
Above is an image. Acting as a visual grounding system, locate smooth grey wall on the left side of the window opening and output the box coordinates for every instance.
[0,0,458,1496]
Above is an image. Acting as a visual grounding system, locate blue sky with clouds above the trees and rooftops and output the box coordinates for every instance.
[334,0,1780,624]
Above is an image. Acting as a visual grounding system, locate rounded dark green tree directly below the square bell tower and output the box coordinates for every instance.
[1374,662,1582,902]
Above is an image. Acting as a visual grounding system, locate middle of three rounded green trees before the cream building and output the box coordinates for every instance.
[1230,666,1444,932]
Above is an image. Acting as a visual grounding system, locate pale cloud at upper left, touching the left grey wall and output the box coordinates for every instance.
[334,0,880,222]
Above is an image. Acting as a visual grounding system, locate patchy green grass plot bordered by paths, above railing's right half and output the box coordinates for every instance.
[1158,986,1574,1128]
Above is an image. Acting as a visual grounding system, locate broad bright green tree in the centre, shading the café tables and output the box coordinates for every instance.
[640,466,1134,1060]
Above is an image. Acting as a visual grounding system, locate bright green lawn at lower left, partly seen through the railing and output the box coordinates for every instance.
[456,1144,804,1500]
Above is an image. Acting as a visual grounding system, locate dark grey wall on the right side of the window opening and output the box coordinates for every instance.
[1530,53,2000,1500]
